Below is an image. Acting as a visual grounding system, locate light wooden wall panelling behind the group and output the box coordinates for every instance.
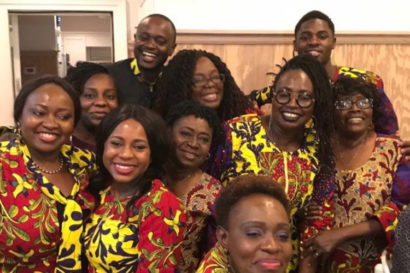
[129,32,410,139]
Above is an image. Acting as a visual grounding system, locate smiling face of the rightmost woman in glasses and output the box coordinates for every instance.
[335,93,373,135]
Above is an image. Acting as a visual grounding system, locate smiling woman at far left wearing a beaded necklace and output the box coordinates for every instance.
[0,76,95,272]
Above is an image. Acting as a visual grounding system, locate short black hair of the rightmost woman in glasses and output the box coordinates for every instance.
[333,76,383,124]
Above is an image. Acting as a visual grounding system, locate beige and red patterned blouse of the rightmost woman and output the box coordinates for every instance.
[326,136,410,273]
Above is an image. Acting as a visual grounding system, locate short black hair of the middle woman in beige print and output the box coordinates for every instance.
[166,100,222,140]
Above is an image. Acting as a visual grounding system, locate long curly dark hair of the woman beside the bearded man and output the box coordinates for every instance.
[154,49,253,121]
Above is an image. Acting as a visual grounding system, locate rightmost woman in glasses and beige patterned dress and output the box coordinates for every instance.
[305,78,410,273]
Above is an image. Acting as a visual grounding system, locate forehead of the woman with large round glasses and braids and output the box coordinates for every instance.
[276,69,313,90]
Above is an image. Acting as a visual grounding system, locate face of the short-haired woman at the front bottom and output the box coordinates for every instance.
[218,194,292,273]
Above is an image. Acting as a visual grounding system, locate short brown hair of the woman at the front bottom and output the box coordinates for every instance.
[215,174,290,229]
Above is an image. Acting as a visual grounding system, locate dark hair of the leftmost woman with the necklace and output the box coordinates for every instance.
[13,75,81,126]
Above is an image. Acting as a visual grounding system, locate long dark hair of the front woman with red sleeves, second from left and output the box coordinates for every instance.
[87,104,170,218]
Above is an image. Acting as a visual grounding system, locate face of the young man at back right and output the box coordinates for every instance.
[293,18,336,65]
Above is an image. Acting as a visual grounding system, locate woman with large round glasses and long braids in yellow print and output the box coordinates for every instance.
[199,55,332,272]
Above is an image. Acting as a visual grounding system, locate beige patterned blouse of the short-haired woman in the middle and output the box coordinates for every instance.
[180,173,222,272]
